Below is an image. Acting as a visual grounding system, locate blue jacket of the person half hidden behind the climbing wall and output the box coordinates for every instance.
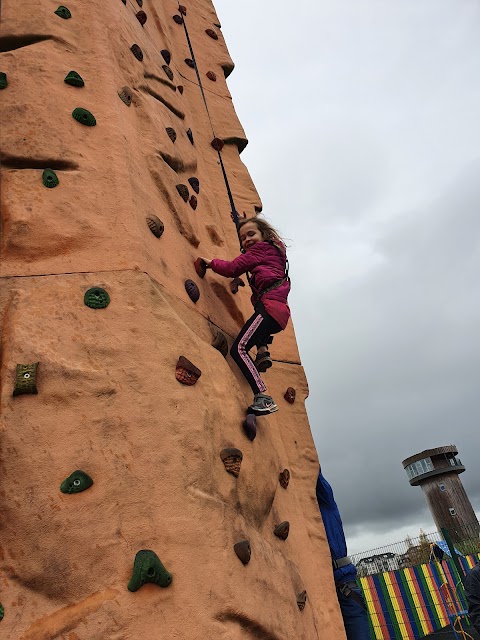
[316,471,357,582]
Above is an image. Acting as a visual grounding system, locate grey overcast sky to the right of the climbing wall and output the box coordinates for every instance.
[214,0,480,553]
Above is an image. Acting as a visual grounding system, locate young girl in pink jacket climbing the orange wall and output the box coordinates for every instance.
[202,217,290,416]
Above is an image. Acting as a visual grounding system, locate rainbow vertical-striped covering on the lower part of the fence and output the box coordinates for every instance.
[358,554,480,640]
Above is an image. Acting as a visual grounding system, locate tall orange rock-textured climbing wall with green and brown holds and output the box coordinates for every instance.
[0,0,344,640]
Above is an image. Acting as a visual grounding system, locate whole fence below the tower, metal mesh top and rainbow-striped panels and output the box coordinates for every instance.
[353,523,480,640]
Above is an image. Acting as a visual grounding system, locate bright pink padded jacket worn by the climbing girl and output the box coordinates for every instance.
[210,242,290,329]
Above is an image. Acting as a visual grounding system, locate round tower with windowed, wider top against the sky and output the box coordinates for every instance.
[402,444,479,541]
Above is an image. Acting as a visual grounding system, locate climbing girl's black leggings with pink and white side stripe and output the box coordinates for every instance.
[230,303,282,394]
